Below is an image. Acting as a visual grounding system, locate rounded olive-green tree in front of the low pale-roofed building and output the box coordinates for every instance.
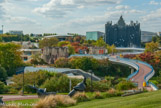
[39,37,59,48]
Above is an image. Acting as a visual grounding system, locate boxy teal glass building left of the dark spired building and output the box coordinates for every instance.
[86,31,105,41]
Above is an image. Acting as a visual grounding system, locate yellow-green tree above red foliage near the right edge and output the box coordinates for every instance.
[145,42,159,52]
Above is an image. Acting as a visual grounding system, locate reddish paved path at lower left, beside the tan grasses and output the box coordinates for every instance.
[0,95,38,101]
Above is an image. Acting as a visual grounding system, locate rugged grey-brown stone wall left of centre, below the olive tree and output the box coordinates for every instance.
[42,47,69,64]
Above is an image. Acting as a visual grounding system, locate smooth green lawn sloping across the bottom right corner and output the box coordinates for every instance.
[70,91,161,108]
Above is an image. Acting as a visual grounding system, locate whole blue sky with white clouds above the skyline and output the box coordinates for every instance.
[0,0,161,34]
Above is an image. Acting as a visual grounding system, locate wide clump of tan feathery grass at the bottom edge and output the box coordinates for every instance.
[34,95,76,108]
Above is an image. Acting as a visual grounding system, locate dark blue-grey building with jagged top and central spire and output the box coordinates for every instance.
[105,16,141,47]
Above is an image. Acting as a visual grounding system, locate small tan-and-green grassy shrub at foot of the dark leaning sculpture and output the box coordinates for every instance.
[73,92,90,102]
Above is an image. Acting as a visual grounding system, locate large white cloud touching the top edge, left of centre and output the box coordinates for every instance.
[33,0,121,18]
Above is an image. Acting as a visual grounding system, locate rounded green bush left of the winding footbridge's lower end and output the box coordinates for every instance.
[116,81,135,90]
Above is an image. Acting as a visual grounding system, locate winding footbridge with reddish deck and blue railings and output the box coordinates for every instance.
[70,54,158,90]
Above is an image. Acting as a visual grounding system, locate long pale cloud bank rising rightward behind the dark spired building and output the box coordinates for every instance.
[52,8,142,34]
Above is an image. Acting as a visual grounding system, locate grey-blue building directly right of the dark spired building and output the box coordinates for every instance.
[141,31,157,43]
